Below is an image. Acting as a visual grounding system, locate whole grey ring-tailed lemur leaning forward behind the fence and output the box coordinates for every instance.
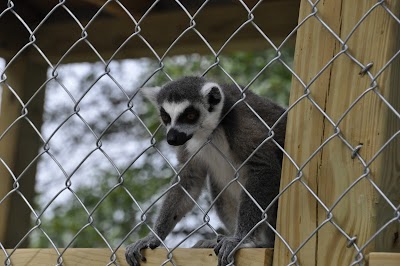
[126,77,286,266]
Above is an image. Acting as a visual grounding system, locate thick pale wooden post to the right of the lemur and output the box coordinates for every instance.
[274,0,400,266]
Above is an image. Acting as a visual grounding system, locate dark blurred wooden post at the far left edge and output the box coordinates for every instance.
[0,56,47,248]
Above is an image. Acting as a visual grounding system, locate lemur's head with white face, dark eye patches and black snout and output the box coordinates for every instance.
[143,78,223,146]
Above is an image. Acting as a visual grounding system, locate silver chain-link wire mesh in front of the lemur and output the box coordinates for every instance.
[0,0,400,265]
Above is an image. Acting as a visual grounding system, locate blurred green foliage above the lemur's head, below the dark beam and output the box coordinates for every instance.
[150,48,294,106]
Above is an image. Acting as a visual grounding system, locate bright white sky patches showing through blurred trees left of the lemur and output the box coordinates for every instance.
[36,60,144,198]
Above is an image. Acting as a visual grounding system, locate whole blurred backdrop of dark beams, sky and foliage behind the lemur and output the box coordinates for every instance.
[0,0,298,248]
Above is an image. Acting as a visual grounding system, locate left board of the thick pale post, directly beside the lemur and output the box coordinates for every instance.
[274,1,340,266]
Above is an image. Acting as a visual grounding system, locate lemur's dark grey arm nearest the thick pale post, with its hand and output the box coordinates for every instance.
[214,151,281,266]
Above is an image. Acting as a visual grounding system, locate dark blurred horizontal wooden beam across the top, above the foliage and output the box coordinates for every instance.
[17,0,299,63]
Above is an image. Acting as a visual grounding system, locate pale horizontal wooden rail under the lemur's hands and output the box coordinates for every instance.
[0,248,273,266]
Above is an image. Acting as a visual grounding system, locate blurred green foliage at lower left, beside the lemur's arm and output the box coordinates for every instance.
[31,163,171,248]
